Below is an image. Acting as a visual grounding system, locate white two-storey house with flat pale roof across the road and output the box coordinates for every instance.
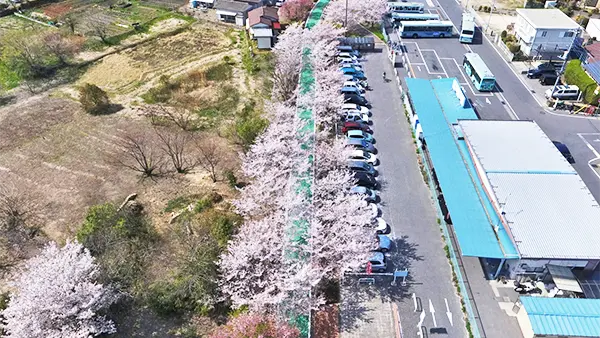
[515,8,580,59]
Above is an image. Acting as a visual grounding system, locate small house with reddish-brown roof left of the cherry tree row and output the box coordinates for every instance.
[246,6,281,49]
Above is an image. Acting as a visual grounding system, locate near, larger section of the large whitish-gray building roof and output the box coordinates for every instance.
[487,174,600,259]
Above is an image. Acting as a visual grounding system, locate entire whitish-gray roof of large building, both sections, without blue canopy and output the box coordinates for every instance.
[458,120,600,259]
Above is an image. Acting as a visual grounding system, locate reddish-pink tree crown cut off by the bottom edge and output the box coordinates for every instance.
[210,314,300,338]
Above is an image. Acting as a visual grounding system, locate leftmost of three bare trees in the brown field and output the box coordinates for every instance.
[116,134,165,177]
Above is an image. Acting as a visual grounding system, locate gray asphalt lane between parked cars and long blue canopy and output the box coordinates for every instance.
[363,45,467,337]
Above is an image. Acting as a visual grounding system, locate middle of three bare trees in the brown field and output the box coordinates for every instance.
[155,128,196,174]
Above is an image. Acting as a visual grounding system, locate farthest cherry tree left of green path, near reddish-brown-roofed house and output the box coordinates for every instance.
[273,23,304,102]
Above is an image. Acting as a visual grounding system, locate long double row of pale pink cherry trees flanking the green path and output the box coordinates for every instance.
[220,23,375,322]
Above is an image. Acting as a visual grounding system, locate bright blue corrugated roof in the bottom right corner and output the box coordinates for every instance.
[520,297,600,337]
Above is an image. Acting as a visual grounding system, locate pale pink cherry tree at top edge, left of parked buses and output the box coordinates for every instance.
[324,0,387,27]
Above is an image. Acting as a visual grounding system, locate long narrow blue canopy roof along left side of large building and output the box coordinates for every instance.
[406,78,516,258]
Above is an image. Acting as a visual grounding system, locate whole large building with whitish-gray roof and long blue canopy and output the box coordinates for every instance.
[405,78,600,280]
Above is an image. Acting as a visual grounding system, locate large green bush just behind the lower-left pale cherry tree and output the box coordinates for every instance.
[77,203,156,287]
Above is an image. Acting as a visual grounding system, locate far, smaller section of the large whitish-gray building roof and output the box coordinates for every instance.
[459,120,576,173]
